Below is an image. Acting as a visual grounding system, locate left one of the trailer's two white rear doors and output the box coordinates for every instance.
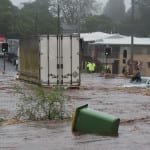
[40,36,59,85]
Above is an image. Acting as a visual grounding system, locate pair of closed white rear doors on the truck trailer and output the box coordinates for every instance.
[40,35,80,85]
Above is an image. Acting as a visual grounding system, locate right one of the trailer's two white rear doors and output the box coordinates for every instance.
[61,36,79,85]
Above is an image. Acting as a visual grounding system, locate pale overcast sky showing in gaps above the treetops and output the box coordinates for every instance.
[10,0,131,9]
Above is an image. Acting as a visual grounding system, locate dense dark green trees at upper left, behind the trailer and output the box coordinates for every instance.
[0,0,57,37]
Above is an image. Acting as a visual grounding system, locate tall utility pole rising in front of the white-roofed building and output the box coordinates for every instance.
[131,0,134,74]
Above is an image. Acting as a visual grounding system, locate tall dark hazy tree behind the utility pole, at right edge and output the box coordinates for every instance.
[120,0,150,36]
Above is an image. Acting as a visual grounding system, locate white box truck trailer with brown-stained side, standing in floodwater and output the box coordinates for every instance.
[19,35,80,87]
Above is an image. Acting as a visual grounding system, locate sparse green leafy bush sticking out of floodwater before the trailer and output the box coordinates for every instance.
[16,86,69,120]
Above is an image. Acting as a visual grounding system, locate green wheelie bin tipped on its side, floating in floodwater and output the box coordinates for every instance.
[72,104,120,136]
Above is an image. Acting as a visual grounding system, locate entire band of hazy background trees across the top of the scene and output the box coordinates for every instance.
[0,0,150,38]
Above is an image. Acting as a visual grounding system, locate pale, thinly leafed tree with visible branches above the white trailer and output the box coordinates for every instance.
[50,0,101,25]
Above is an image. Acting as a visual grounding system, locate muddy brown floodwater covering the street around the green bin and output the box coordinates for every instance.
[0,60,150,150]
